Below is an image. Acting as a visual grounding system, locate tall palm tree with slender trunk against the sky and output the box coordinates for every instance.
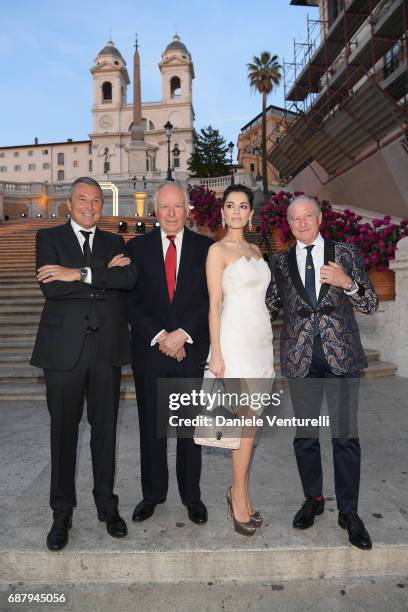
[247,51,282,195]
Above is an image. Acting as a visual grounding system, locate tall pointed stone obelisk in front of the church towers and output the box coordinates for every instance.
[127,37,147,176]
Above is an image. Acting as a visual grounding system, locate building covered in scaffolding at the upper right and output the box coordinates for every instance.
[268,0,408,216]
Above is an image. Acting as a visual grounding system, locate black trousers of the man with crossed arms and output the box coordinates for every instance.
[44,330,121,512]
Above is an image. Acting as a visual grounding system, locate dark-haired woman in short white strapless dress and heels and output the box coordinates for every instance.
[205,185,274,535]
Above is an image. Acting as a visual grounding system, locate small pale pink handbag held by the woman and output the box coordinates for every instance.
[194,378,241,449]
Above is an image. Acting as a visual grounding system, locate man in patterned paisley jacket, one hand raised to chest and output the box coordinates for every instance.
[267,196,378,550]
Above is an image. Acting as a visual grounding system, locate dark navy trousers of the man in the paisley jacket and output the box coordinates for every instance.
[289,336,360,512]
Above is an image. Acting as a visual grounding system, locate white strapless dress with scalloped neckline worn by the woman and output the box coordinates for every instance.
[204,256,275,412]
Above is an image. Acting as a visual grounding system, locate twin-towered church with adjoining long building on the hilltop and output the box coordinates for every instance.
[0,36,194,183]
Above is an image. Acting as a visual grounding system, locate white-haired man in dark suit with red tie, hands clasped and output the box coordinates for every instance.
[126,183,212,523]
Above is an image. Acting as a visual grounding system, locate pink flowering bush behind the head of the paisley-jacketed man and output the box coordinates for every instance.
[260,191,408,271]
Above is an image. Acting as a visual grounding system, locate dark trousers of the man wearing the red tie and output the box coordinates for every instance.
[133,370,202,504]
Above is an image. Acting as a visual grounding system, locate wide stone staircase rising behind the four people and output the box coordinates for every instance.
[0,218,397,401]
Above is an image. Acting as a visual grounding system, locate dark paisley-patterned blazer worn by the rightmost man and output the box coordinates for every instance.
[266,240,378,378]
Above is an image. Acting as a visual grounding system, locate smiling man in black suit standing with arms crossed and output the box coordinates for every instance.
[31,177,136,551]
